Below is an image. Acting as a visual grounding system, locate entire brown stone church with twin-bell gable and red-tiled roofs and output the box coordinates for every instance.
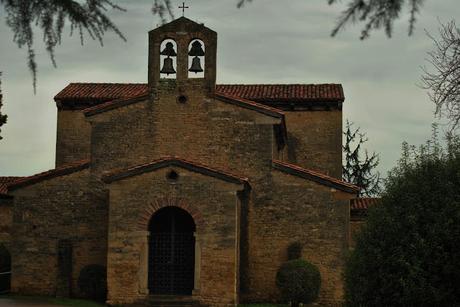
[0,17,358,306]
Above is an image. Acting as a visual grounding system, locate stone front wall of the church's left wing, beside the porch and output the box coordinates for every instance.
[11,169,107,296]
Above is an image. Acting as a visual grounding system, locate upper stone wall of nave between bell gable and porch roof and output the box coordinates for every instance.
[89,94,280,178]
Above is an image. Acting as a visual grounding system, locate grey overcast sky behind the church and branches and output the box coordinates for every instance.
[0,0,460,176]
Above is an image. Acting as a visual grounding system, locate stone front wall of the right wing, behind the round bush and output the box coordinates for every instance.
[242,171,353,306]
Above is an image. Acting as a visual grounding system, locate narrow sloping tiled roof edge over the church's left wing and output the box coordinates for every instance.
[8,160,90,191]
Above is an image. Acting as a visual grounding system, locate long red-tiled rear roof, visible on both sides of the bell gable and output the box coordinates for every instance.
[54,83,345,109]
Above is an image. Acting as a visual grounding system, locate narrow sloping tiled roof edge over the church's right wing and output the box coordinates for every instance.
[272,160,359,193]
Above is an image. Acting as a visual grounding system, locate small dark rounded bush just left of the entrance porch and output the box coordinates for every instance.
[78,264,107,301]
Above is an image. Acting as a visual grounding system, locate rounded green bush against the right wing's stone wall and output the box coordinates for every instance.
[276,259,321,306]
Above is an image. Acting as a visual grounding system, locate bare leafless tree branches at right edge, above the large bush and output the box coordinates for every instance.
[422,21,460,129]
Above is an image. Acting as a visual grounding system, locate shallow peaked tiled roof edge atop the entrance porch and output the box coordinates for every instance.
[102,156,248,185]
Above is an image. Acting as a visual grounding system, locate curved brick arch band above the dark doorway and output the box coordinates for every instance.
[138,197,203,231]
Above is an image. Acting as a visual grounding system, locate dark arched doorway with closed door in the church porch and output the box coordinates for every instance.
[148,207,196,295]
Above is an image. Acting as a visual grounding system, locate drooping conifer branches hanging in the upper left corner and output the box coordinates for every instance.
[0,0,125,89]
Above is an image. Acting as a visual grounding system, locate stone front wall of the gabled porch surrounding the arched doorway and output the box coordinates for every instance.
[108,167,243,306]
